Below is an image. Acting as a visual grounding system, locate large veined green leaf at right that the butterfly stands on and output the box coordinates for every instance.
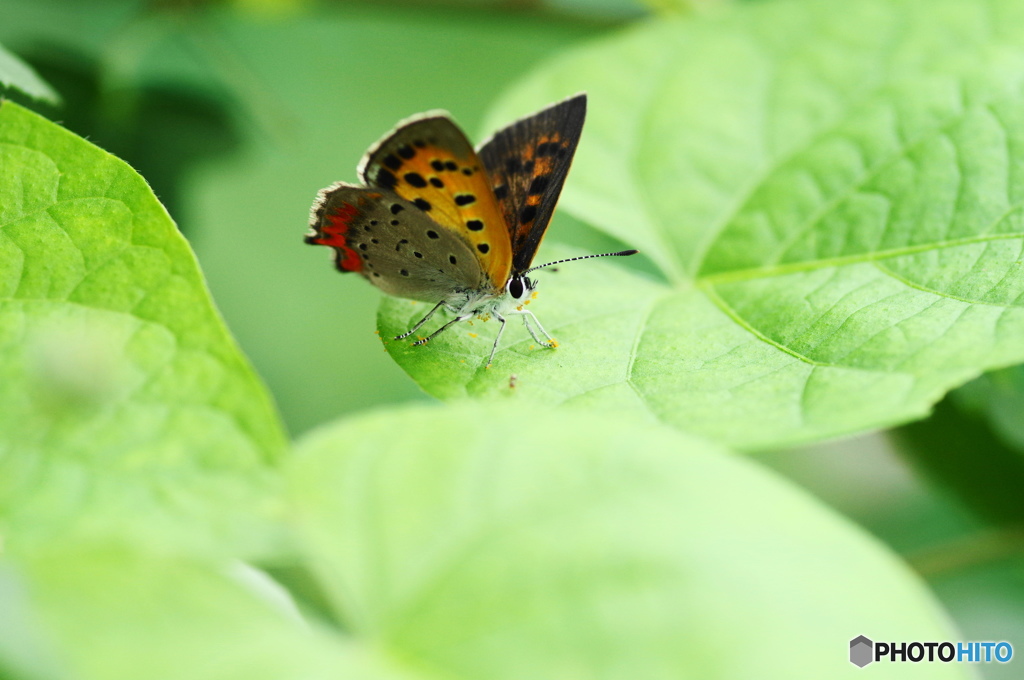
[380,0,1024,449]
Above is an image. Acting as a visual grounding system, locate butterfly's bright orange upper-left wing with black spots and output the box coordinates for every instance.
[359,113,520,289]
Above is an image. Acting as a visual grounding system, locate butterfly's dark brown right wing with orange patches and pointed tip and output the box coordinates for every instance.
[479,94,587,273]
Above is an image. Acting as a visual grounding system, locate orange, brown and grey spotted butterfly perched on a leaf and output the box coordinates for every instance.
[306,94,637,367]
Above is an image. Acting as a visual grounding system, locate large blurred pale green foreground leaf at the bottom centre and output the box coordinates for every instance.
[289,399,971,680]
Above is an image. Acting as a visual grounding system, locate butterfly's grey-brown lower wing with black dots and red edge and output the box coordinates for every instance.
[306,182,488,302]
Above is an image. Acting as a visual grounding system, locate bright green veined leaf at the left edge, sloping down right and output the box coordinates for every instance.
[0,102,284,549]
